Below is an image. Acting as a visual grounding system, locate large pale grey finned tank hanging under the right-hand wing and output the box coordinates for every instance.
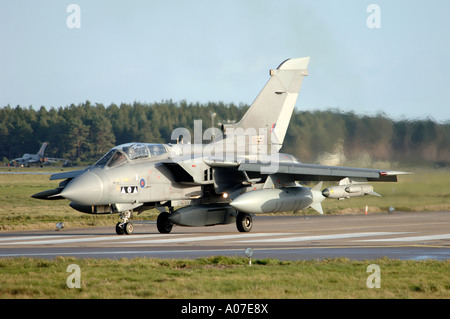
[230,182,325,214]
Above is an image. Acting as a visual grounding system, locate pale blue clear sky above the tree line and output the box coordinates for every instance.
[0,0,450,122]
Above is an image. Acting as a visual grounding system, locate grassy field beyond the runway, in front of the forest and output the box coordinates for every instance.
[0,168,450,230]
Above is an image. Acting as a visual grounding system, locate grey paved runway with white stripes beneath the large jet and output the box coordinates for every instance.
[0,212,450,260]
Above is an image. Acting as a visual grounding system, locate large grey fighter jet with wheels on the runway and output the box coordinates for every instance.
[32,57,404,235]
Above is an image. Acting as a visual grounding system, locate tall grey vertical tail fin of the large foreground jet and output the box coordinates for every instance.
[223,57,309,153]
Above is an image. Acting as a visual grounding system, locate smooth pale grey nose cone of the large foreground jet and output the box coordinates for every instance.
[60,172,103,205]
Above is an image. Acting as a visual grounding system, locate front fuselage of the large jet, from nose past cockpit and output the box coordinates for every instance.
[61,143,201,211]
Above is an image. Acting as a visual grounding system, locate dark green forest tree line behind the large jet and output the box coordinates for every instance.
[0,100,450,167]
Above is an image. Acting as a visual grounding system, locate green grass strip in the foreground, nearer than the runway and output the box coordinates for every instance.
[0,256,450,299]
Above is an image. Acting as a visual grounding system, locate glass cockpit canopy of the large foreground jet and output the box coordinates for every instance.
[94,143,167,167]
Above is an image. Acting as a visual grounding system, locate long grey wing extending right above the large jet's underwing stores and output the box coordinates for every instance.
[238,163,409,182]
